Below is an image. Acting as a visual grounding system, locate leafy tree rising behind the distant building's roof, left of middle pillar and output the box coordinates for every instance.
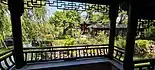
[86,5,109,24]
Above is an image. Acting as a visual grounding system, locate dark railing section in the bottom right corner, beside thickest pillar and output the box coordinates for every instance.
[134,59,155,70]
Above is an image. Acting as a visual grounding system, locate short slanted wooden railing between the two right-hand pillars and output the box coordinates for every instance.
[113,46,125,63]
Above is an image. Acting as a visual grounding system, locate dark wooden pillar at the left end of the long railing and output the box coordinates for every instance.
[8,0,25,69]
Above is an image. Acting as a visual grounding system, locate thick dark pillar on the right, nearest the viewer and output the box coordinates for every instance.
[123,2,138,70]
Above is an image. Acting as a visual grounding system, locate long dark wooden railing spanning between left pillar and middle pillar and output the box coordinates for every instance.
[24,45,108,63]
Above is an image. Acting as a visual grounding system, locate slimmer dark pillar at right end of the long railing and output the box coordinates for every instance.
[108,4,119,59]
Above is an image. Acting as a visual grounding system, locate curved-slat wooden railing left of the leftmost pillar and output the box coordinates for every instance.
[0,50,15,70]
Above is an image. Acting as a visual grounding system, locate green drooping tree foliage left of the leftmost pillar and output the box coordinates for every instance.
[0,4,11,47]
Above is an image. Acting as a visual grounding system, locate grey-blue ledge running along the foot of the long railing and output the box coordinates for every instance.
[19,57,123,70]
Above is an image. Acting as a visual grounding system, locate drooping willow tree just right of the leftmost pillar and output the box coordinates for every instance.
[22,7,47,41]
